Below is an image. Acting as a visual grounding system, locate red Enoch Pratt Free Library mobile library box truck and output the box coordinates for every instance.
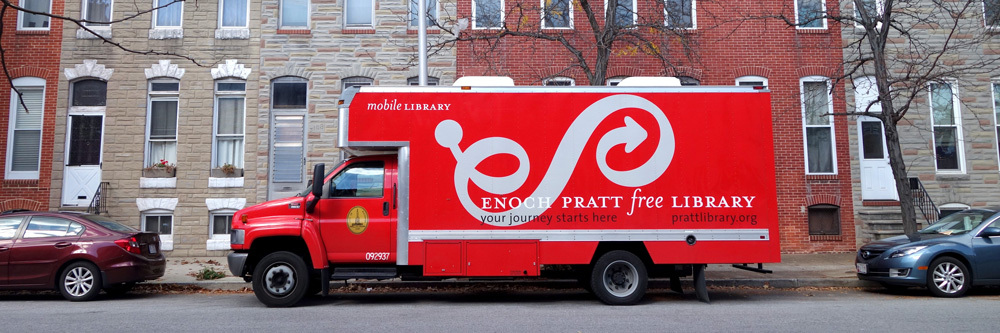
[228,80,780,306]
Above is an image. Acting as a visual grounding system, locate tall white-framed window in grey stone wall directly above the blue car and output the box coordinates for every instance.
[930,83,965,172]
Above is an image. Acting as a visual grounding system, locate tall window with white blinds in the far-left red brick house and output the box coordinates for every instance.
[5,77,45,179]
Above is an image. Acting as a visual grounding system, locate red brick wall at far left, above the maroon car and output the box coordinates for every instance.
[0,0,64,211]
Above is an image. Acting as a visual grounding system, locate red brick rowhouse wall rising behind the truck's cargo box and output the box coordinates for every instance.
[457,0,855,253]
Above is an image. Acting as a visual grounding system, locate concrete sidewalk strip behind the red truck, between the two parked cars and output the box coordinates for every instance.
[145,252,871,290]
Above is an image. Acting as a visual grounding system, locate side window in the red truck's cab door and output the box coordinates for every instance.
[328,161,385,198]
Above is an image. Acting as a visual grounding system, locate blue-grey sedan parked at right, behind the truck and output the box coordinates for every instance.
[855,208,1000,297]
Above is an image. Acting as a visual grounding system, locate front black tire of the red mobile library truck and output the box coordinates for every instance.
[253,251,309,307]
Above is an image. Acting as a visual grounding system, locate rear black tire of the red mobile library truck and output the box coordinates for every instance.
[590,250,649,305]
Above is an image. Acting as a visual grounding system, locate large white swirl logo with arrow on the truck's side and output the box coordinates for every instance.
[434,95,674,226]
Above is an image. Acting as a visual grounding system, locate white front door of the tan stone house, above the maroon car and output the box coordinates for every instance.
[62,115,104,206]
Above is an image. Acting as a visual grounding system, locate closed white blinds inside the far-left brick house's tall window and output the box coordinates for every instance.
[11,88,43,171]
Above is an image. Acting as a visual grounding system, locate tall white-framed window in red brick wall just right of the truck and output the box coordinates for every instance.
[801,77,837,174]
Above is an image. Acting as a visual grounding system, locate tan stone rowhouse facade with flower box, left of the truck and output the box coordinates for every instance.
[49,0,265,256]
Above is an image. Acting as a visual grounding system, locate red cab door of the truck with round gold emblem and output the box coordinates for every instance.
[314,158,396,263]
